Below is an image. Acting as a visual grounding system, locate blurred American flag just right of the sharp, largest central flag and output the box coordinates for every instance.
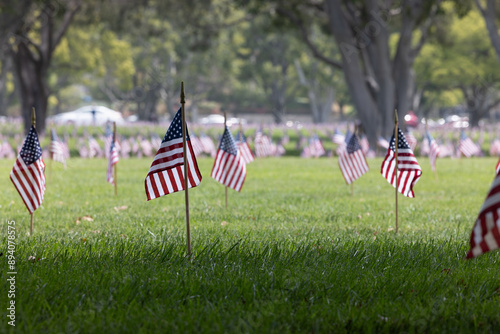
[212,126,247,191]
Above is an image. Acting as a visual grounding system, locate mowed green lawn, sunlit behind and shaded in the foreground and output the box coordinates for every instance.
[0,158,500,334]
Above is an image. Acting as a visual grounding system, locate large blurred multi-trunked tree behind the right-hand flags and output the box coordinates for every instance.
[244,0,441,143]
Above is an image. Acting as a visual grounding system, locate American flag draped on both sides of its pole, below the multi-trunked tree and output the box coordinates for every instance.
[380,128,422,197]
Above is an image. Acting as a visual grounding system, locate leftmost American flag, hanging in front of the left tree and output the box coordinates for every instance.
[10,126,45,213]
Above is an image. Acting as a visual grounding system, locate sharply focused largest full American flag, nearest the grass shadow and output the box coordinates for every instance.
[144,108,201,201]
